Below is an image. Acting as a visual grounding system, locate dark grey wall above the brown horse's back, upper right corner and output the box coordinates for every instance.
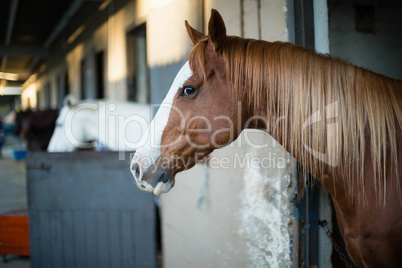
[328,0,402,79]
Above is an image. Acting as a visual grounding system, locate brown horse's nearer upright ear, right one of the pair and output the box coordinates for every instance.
[208,9,226,51]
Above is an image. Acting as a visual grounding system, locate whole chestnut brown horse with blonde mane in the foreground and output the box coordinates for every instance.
[131,10,402,267]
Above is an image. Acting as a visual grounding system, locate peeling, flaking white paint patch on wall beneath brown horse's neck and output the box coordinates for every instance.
[239,141,292,267]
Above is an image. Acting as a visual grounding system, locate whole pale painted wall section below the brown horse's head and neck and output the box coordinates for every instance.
[162,131,291,267]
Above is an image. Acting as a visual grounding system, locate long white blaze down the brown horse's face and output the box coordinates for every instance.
[133,61,193,181]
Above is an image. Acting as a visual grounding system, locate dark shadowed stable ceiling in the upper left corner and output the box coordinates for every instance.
[0,0,89,86]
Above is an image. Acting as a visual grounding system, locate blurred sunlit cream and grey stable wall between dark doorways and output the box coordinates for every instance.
[22,0,202,109]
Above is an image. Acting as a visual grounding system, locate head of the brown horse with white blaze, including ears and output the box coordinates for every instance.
[131,10,248,195]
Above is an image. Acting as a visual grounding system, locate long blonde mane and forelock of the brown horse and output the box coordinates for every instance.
[189,36,402,204]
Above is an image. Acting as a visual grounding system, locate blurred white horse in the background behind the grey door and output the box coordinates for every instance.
[47,97,151,152]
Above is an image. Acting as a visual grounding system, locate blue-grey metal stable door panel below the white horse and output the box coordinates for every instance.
[26,152,156,268]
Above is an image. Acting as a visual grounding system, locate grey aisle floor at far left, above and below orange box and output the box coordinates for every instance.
[0,136,31,268]
